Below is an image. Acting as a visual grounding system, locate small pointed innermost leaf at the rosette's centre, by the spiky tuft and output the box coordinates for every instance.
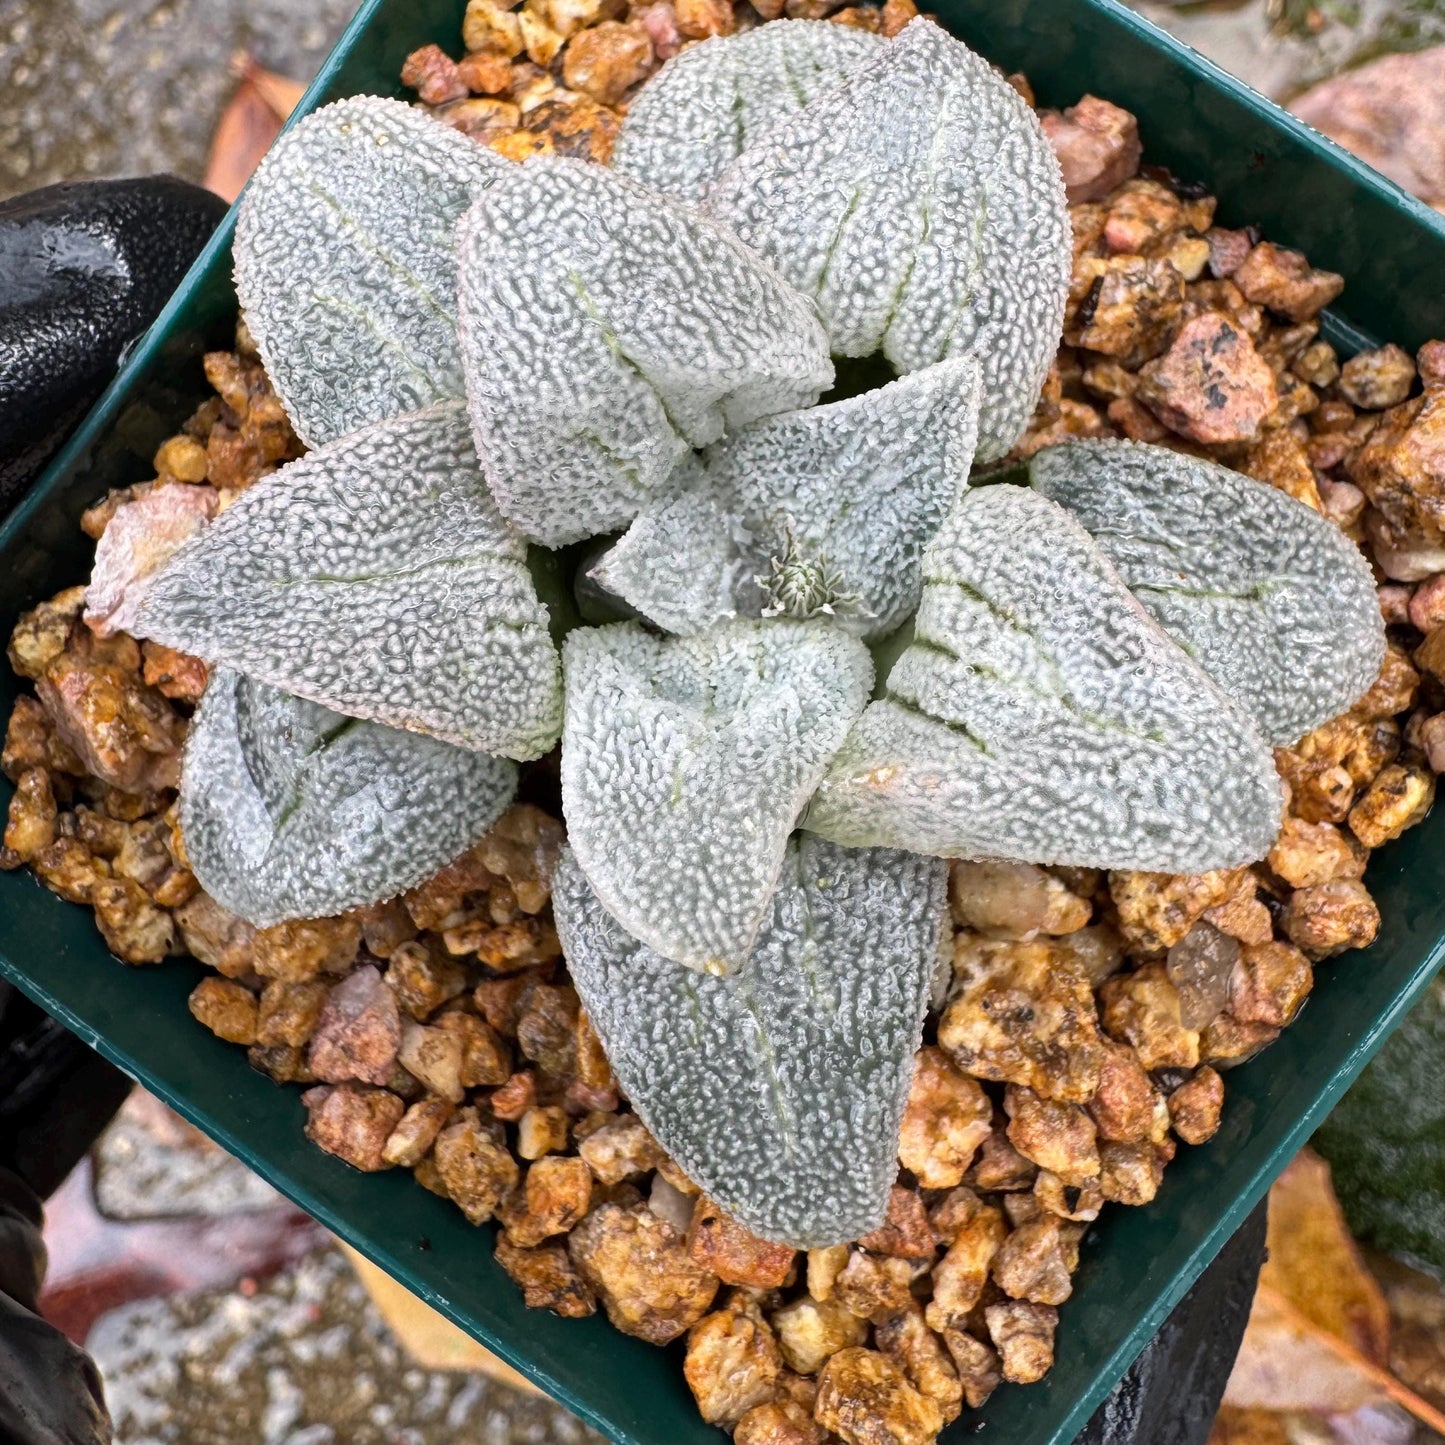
[594,355,978,637]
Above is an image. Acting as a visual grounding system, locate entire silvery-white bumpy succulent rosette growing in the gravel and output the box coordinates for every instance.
[104,19,1384,1246]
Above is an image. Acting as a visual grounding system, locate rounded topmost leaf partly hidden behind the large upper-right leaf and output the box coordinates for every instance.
[613,20,887,204]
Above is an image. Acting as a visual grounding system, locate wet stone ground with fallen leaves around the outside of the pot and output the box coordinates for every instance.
[0,0,1445,1445]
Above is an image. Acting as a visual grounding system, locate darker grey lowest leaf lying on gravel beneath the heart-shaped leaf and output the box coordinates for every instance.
[552,835,946,1248]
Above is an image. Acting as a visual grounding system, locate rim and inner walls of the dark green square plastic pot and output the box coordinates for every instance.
[0,0,1445,1445]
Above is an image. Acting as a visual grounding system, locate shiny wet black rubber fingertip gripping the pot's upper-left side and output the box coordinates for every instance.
[0,176,225,516]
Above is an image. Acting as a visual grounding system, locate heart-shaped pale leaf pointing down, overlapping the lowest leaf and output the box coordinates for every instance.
[562,621,873,972]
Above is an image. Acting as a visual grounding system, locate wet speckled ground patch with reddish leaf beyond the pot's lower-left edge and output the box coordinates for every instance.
[40,1090,600,1445]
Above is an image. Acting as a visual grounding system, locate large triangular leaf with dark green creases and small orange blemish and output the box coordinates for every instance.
[803,486,1282,873]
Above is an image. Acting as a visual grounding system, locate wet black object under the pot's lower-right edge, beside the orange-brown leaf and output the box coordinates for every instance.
[1074,1204,1266,1445]
